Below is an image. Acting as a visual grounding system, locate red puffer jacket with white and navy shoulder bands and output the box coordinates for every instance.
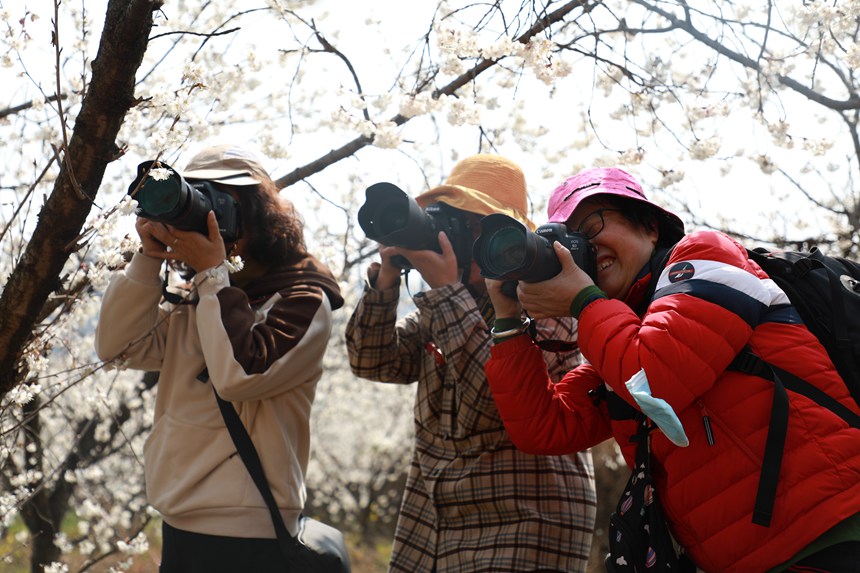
[486,231,860,573]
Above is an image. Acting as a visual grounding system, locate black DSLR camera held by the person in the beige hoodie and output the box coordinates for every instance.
[128,161,241,243]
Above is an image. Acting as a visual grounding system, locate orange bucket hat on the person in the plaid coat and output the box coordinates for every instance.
[415,153,535,230]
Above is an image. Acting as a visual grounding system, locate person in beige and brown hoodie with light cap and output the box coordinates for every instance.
[96,145,343,573]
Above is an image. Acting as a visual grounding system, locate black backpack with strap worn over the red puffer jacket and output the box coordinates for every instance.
[729,248,860,527]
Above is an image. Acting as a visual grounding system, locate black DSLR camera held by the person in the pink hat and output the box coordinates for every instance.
[473,213,597,296]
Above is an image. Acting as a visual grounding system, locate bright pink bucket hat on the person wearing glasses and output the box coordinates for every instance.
[547,167,684,243]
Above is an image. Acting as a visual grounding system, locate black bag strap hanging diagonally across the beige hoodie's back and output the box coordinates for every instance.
[212,385,299,564]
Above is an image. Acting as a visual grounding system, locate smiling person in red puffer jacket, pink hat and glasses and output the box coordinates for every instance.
[485,168,860,573]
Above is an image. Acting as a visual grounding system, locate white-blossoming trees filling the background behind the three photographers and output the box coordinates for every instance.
[0,0,860,571]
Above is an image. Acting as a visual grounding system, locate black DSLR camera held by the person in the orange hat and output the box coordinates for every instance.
[358,183,472,269]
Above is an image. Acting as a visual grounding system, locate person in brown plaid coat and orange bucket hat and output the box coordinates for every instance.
[346,154,596,573]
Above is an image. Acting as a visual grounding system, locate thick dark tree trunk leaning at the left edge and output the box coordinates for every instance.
[0,0,163,397]
